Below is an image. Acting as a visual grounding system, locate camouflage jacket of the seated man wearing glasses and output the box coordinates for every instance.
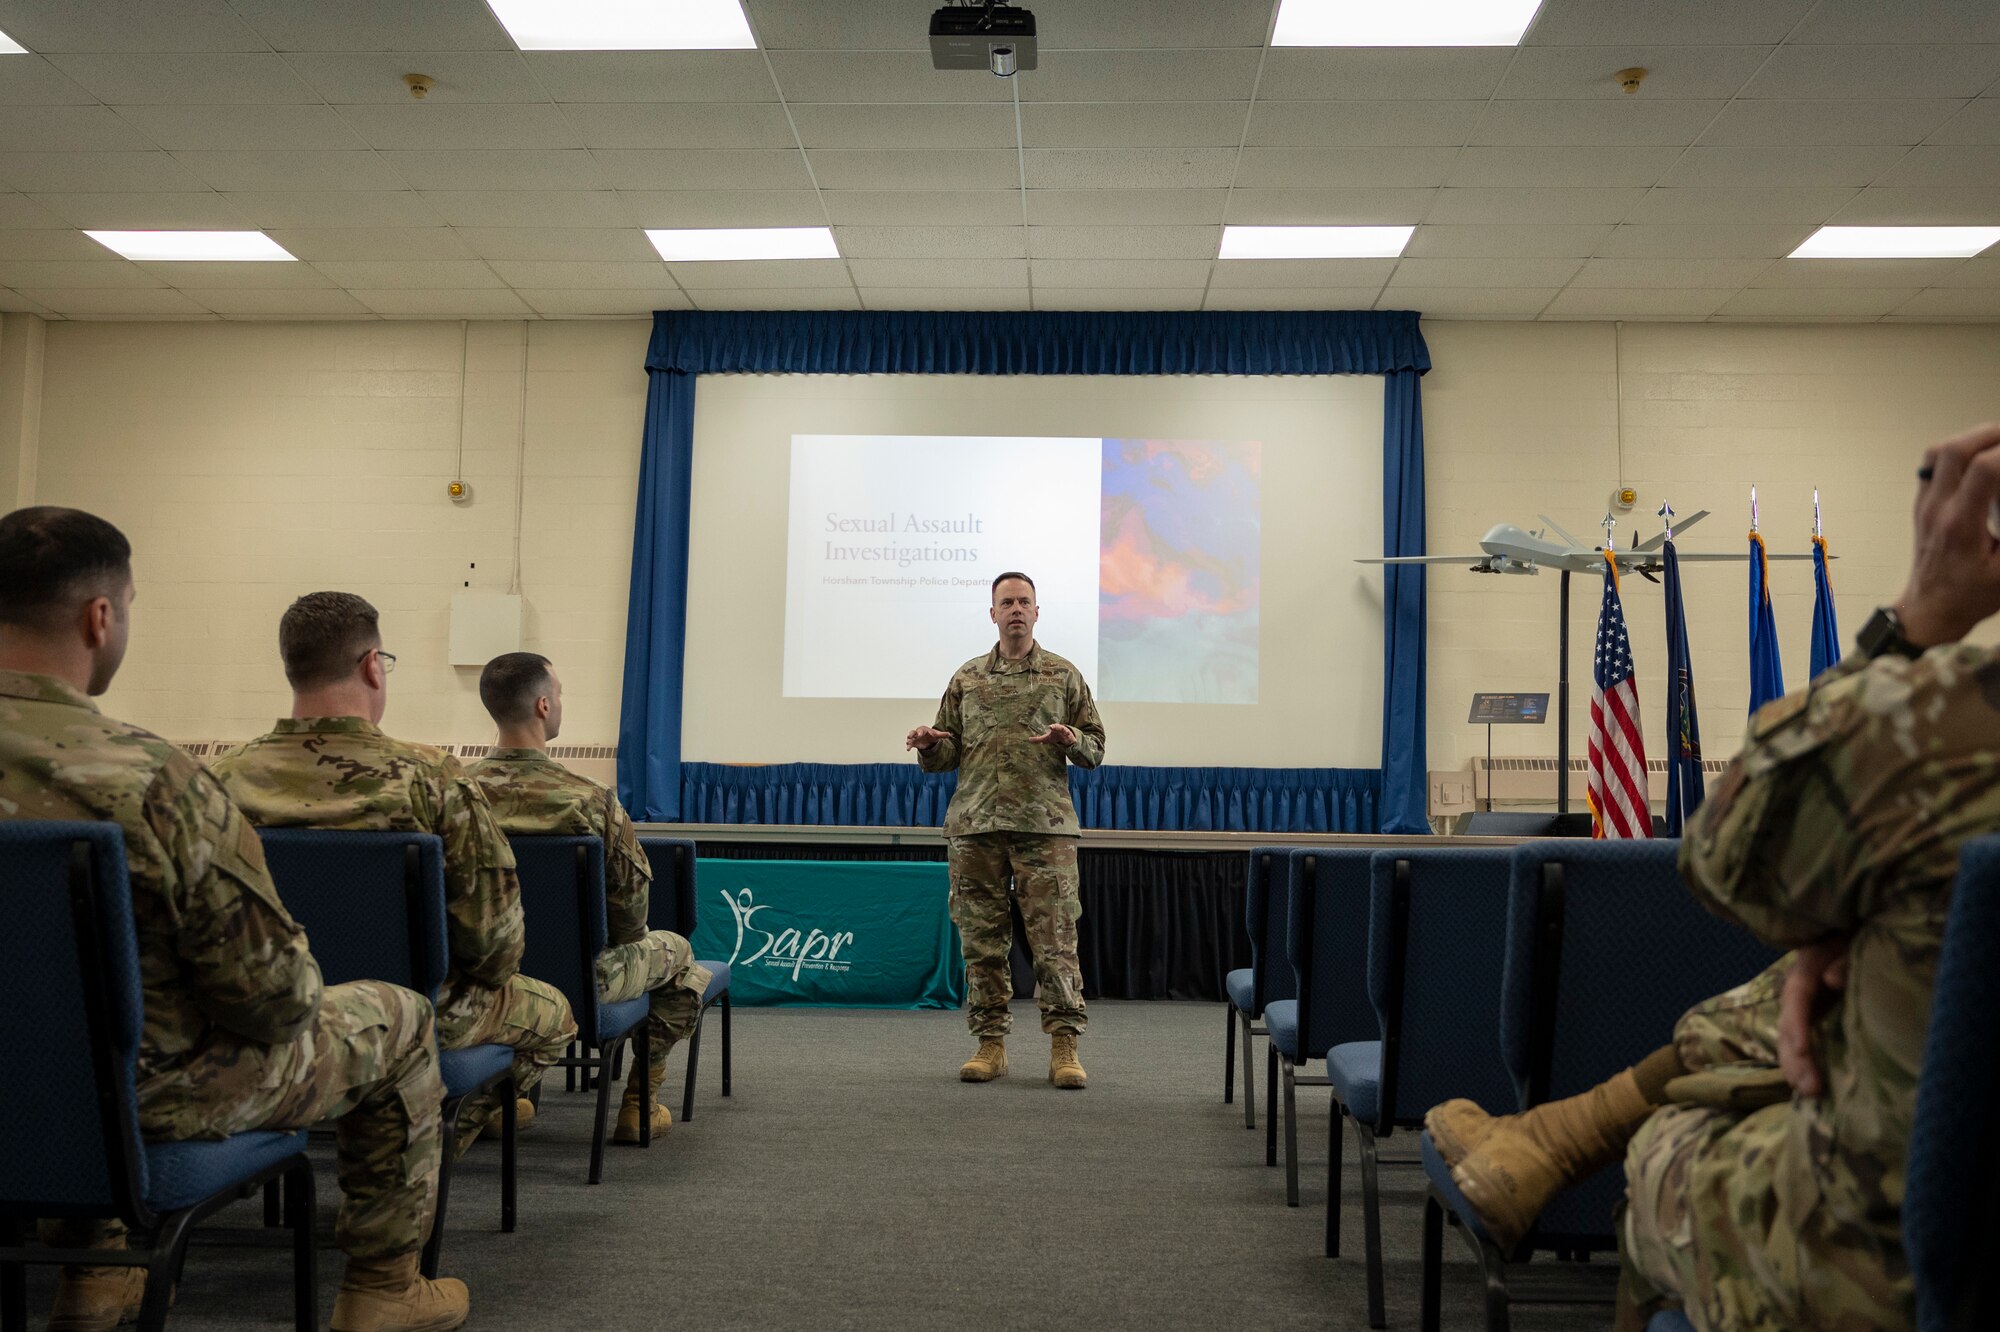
[212,716,522,1012]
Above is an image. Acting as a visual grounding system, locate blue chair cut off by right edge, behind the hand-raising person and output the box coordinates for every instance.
[1902,838,2000,1332]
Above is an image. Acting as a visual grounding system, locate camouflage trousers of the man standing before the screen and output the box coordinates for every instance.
[950,832,1084,1036]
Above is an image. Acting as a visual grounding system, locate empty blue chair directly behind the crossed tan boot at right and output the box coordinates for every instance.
[1422,838,1778,1330]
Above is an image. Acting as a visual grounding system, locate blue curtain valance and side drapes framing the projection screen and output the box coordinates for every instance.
[618,310,1430,832]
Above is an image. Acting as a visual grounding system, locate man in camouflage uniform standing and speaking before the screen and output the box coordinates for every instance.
[904,572,1104,1088]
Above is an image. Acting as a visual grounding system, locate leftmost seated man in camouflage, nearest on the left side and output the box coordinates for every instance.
[0,508,466,1332]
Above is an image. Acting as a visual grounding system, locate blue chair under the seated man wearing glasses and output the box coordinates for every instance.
[258,828,516,1276]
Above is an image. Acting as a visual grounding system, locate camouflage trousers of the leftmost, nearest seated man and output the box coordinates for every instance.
[40,980,444,1260]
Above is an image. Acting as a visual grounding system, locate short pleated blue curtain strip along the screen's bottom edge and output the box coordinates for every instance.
[680,764,1382,832]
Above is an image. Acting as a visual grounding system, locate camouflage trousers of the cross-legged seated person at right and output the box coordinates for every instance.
[1620,954,1910,1332]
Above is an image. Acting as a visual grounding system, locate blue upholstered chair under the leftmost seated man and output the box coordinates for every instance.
[0,820,318,1332]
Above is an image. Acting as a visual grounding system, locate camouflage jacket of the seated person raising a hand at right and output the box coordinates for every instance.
[1680,644,2000,1298]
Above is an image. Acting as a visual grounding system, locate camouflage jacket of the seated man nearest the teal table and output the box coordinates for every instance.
[466,748,652,948]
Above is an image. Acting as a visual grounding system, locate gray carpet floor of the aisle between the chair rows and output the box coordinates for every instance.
[30,1000,1610,1332]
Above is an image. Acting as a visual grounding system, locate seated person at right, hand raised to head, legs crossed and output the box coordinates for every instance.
[1426,426,2000,1332]
